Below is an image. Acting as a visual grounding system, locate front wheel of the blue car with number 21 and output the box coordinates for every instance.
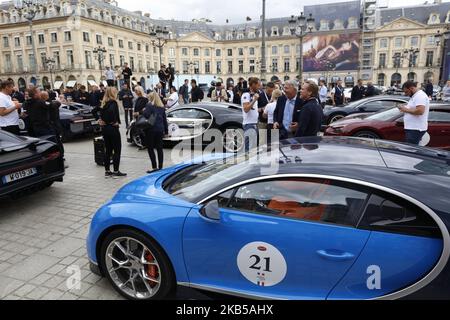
[99,229,176,301]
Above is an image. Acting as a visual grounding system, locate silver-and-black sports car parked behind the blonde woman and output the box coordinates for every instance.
[127,102,244,152]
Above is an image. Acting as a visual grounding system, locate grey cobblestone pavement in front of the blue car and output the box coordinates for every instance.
[0,127,209,300]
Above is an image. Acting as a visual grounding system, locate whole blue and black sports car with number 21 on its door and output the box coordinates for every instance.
[87,137,450,300]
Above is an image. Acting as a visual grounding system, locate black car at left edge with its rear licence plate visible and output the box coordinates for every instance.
[0,130,64,197]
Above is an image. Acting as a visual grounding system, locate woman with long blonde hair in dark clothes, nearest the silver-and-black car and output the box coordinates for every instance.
[144,92,169,173]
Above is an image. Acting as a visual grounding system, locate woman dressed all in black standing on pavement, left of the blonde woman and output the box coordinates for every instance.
[93,87,126,178]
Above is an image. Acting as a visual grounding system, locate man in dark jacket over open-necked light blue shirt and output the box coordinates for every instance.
[273,80,303,140]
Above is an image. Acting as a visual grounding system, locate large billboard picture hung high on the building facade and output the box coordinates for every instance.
[303,33,361,72]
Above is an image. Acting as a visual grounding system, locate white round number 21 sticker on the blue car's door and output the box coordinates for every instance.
[237,242,287,287]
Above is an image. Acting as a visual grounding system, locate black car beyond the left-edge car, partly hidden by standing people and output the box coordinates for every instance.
[20,103,101,141]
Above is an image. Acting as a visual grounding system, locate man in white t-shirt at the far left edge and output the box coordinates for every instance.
[0,81,22,135]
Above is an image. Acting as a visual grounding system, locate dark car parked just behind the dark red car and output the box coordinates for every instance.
[323,96,409,128]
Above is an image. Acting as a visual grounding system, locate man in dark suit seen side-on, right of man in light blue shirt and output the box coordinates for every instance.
[292,81,323,137]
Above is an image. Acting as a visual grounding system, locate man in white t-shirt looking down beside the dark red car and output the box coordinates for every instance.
[399,81,430,145]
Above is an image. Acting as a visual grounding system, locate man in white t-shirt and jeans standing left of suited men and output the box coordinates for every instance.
[241,78,260,152]
